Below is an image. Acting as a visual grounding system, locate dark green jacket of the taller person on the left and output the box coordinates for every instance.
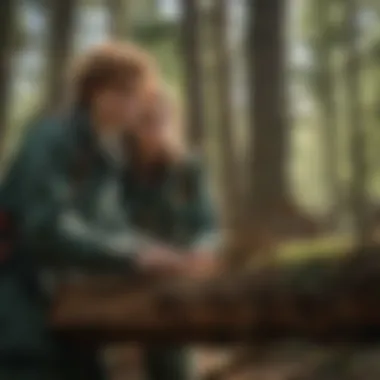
[0,109,154,366]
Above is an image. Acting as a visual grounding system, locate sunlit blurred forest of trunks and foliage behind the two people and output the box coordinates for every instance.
[0,0,380,262]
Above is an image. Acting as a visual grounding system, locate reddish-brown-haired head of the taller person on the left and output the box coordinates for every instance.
[72,42,158,134]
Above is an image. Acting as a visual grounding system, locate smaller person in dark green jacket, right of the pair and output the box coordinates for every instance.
[123,91,221,380]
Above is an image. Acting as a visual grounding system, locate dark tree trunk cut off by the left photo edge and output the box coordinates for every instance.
[0,0,17,148]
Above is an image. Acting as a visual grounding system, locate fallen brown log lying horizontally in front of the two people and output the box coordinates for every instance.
[51,247,380,343]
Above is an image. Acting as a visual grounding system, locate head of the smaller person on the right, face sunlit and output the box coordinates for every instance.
[130,89,184,165]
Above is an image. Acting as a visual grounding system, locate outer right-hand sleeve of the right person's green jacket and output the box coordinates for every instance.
[185,160,222,253]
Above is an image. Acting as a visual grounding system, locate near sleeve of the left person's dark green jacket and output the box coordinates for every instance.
[14,120,151,271]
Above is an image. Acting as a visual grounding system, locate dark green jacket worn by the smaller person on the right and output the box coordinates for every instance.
[123,157,220,254]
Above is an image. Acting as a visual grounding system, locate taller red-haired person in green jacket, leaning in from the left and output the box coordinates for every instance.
[0,43,186,380]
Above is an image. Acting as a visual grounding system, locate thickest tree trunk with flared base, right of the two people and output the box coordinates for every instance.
[242,0,320,252]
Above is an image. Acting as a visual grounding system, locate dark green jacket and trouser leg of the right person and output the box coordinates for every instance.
[123,157,217,380]
